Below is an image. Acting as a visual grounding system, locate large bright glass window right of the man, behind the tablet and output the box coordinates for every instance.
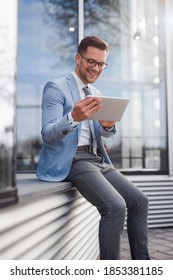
[84,0,168,172]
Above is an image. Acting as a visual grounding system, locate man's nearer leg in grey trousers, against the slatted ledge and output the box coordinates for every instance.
[66,152,126,260]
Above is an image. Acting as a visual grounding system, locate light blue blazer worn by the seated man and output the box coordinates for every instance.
[36,73,115,181]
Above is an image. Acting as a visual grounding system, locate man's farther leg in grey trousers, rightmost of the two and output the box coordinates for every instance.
[103,166,150,260]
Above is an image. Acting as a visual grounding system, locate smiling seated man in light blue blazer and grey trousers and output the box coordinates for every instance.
[37,36,149,260]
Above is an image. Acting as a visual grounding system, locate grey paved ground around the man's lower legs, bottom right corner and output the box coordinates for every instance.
[121,227,173,260]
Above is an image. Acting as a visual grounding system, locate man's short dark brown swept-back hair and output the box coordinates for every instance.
[78,36,109,54]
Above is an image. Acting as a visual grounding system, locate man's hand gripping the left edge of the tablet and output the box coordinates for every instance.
[71,96,102,122]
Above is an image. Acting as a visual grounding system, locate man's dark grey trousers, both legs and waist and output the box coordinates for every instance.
[66,151,150,260]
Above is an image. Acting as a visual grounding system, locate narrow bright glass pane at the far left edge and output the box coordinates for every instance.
[0,1,17,207]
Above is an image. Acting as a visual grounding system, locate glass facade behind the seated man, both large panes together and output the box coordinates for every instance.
[17,0,168,174]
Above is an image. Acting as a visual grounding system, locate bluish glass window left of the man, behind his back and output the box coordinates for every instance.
[17,0,78,171]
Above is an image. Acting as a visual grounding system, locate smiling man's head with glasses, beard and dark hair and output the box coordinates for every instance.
[76,36,109,84]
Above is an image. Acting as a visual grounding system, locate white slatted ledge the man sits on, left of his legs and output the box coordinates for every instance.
[0,173,100,260]
